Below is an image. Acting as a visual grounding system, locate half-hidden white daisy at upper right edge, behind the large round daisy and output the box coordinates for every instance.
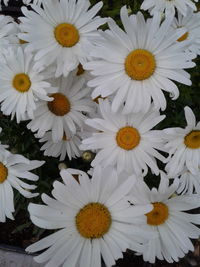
[172,10,200,55]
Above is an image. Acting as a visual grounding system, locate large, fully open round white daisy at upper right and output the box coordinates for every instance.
[84,7,195,113]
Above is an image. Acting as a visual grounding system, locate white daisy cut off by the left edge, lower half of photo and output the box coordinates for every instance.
[0,150,44,222]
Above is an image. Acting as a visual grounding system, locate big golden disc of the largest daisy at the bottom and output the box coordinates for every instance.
[76,203,112,238]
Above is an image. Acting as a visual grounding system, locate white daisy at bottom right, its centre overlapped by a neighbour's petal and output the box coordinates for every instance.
[132,173,200,263]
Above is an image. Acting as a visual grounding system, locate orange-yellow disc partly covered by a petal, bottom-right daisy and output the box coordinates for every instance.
[145,202,169,226]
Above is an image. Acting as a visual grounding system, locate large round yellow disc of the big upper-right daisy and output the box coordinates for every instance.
[125,49,156,81]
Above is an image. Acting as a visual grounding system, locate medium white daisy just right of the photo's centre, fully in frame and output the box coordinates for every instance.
[81,100,165,175]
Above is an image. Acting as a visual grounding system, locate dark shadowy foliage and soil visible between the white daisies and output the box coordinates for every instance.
[0,0,200,267]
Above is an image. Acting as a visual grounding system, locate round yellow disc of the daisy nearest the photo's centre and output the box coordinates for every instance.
[116,126,140,150]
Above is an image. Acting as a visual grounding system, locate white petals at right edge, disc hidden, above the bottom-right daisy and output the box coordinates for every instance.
[177,169,200,195]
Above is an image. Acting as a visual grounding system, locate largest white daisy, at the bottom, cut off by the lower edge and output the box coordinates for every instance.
[26,167,152,267]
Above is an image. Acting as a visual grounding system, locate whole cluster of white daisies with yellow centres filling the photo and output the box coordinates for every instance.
[0,0,200,267]
